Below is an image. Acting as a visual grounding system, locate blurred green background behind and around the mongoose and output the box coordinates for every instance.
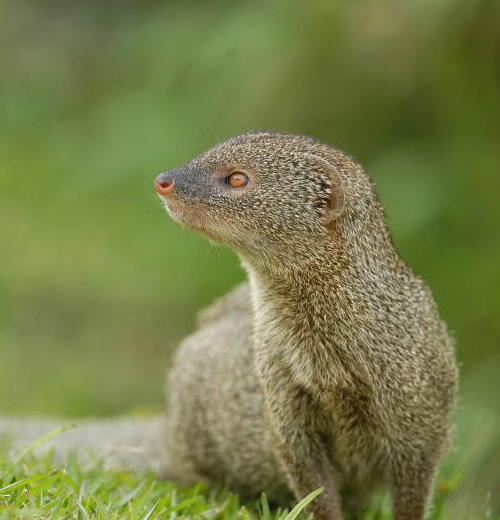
[0,0,500,518]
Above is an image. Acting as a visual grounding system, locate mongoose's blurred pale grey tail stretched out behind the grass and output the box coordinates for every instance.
[0,417,166,475]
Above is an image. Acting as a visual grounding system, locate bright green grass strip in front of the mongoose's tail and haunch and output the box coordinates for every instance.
[0,446,319,520]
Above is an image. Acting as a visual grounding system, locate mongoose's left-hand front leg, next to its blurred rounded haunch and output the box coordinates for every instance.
[266,380,343,520]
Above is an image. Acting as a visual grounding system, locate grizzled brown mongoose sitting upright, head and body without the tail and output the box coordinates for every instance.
[156,132,457,520]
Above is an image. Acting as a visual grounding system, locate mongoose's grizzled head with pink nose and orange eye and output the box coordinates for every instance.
[155,132,382,270]
